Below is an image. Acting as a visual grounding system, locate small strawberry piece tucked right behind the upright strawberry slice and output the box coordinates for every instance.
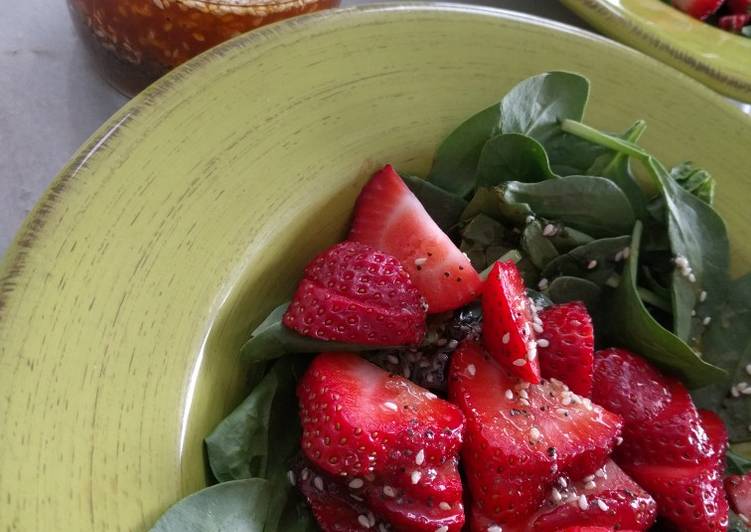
[535,301,595,397]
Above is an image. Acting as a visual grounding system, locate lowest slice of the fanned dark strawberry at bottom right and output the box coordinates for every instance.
[622,463,728,532]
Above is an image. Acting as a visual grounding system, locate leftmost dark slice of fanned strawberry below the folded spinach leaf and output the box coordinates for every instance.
[592,348,671,429]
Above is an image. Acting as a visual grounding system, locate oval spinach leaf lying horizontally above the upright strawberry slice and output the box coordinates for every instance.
[500,176,634,237]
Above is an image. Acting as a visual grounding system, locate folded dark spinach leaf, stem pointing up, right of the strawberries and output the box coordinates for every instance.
[610,222,726,388]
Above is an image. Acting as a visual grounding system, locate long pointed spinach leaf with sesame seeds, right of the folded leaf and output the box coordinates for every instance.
[647,157,730,345]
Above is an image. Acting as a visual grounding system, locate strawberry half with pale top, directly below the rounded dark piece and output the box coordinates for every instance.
[297,353,464,477]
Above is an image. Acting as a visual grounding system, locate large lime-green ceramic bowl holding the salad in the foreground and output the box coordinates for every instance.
[0,3,751,532]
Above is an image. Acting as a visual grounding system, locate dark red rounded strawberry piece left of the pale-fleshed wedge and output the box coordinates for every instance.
[284,242,425,345]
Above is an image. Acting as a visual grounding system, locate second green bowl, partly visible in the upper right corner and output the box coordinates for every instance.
[562,0,751,102]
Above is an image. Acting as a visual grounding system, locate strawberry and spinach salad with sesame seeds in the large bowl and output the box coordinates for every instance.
[153,72,751,532]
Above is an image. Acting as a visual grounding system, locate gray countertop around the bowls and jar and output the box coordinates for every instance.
[0,0,583,256]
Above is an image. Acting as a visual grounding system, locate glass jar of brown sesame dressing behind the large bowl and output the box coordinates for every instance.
[68,0,340,95]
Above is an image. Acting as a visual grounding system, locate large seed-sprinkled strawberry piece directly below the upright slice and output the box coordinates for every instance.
[449,342,621,527]
